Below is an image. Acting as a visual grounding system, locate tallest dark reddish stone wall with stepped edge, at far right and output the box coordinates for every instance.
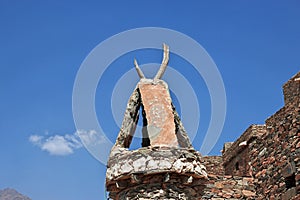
[250,73,300,200]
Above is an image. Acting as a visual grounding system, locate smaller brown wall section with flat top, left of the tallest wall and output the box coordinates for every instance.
[223,125,266,176]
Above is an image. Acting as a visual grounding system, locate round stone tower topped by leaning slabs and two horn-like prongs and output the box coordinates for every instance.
[106,44,207,200]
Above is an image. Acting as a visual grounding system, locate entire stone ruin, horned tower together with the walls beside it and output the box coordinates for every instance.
[106,45,300,200]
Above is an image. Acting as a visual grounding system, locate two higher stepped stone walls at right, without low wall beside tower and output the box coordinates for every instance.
[223,73,300,200]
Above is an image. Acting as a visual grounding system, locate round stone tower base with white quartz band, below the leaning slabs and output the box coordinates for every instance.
[106,146,207,200]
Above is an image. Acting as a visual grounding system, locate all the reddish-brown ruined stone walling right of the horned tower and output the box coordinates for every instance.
[202,73,300,200]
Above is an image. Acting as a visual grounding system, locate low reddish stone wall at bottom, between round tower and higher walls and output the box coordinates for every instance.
[202,175,257,200]
